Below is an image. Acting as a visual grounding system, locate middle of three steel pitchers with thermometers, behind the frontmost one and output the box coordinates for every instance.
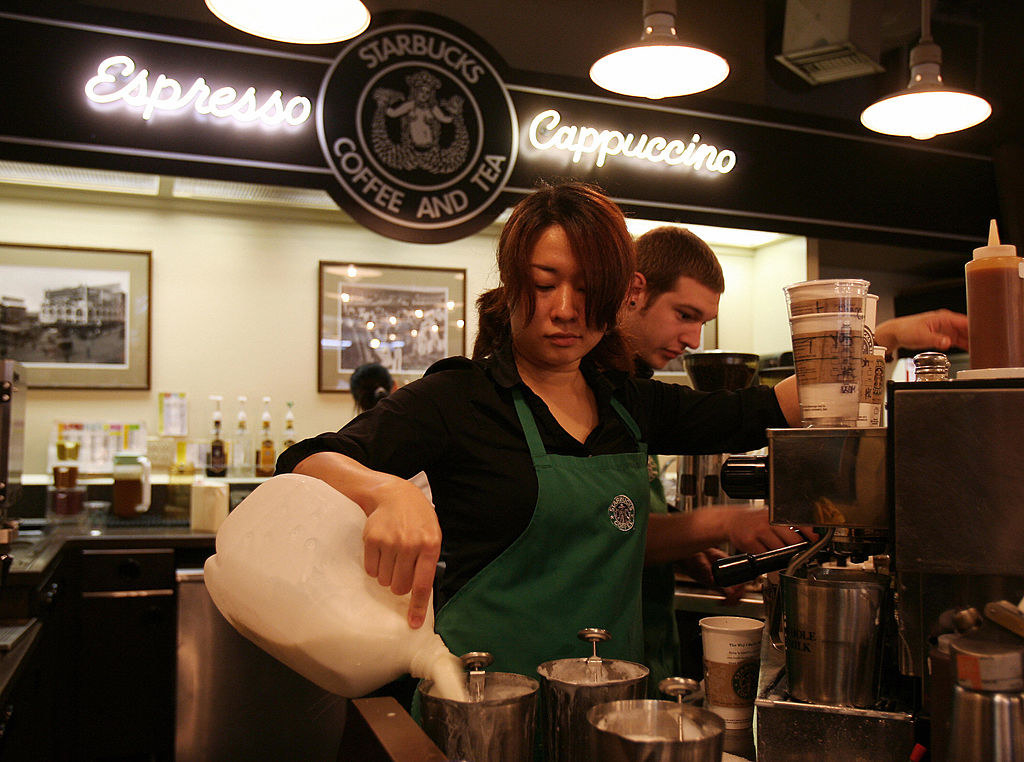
[537,628,649,762]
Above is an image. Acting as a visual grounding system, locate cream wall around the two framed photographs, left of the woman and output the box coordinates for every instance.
[0,186,497,473]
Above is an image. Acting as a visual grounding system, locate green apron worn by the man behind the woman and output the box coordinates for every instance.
[643,455,682,699]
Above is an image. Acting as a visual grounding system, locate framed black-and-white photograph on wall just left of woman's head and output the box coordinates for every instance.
[317,262,466,391]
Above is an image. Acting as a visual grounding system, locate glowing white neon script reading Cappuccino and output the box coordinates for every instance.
[529,109,736,174]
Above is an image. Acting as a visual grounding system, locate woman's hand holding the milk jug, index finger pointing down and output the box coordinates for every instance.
[362,477,441,629]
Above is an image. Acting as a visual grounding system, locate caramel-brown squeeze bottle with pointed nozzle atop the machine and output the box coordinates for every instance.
[964,219,1024,370]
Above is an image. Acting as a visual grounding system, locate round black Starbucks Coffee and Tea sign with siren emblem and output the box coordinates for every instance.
[316,15,518,243]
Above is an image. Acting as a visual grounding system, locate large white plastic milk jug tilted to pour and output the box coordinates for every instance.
[205,474,465,700]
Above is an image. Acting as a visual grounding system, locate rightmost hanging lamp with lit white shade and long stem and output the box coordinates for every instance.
[860,0,992,140]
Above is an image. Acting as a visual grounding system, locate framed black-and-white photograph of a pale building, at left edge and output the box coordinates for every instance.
[0,243,151,389]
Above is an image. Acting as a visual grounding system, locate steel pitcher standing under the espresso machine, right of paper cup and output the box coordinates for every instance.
[780,566,889,708]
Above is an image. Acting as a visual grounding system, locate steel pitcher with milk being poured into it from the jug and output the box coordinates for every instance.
[418,654,540,762]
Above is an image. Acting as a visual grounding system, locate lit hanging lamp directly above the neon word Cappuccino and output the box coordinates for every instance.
[590,0,729,98]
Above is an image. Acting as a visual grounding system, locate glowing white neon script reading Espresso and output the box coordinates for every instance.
[85,55,312,127]
